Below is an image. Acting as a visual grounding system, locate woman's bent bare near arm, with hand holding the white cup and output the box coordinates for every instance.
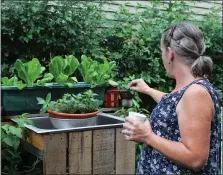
[124,84,214,171]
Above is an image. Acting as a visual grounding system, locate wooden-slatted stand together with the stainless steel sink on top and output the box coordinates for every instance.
[12,113,135,174]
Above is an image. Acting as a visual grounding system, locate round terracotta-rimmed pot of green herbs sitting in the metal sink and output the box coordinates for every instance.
[37,90,102,129]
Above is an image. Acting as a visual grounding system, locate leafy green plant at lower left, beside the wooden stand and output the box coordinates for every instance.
[1,113,33,175]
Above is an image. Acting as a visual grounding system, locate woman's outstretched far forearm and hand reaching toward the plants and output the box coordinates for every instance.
[129,79,166,103]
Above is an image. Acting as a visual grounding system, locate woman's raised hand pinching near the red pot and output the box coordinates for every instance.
[129,79,151,94]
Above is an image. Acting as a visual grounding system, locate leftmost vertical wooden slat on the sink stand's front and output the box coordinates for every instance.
[43,133,67,174]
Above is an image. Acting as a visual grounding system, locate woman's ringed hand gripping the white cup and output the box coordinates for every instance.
[122,117,154,144]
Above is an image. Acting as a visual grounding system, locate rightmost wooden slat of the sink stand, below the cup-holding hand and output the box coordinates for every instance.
[115,128,135,174]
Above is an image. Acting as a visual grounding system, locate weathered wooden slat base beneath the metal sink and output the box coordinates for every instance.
[28,128,135,174]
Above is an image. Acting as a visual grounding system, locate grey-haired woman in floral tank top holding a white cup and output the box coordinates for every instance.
[122,23,220,175]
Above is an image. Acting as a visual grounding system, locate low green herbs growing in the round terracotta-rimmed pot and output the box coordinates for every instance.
[37,90,102,114]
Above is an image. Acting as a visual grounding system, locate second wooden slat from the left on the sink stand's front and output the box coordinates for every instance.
[68,131,92,174]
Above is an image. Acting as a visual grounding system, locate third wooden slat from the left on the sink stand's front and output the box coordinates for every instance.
[92,129,115,174]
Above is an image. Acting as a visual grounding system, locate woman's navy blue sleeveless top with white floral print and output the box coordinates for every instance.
[136,80,220,175]
